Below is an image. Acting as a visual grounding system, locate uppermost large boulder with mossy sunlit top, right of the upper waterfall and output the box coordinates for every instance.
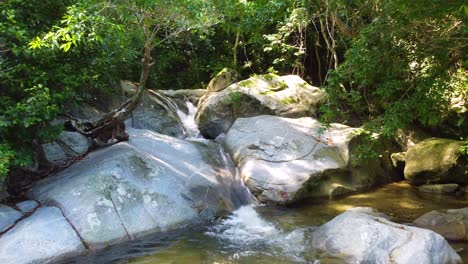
[196,74,325,138]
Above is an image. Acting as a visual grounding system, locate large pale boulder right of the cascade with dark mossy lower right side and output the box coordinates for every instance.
[223,116,397,204]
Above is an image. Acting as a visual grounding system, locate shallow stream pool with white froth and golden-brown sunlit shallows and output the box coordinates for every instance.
[66,182,468,264]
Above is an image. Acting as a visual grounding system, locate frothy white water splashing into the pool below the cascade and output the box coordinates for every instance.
[206,205,306,262]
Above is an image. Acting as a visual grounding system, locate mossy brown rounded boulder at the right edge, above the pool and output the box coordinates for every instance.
[404,138,468,184]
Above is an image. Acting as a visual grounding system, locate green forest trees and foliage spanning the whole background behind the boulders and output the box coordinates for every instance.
[0,0,468,177]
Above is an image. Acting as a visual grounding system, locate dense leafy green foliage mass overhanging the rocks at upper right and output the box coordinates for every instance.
[324,0,466,138]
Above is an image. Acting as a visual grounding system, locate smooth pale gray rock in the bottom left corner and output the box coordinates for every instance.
[0,207,85,264]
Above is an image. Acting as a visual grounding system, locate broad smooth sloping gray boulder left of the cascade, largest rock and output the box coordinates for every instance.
[27,129,250,248]
